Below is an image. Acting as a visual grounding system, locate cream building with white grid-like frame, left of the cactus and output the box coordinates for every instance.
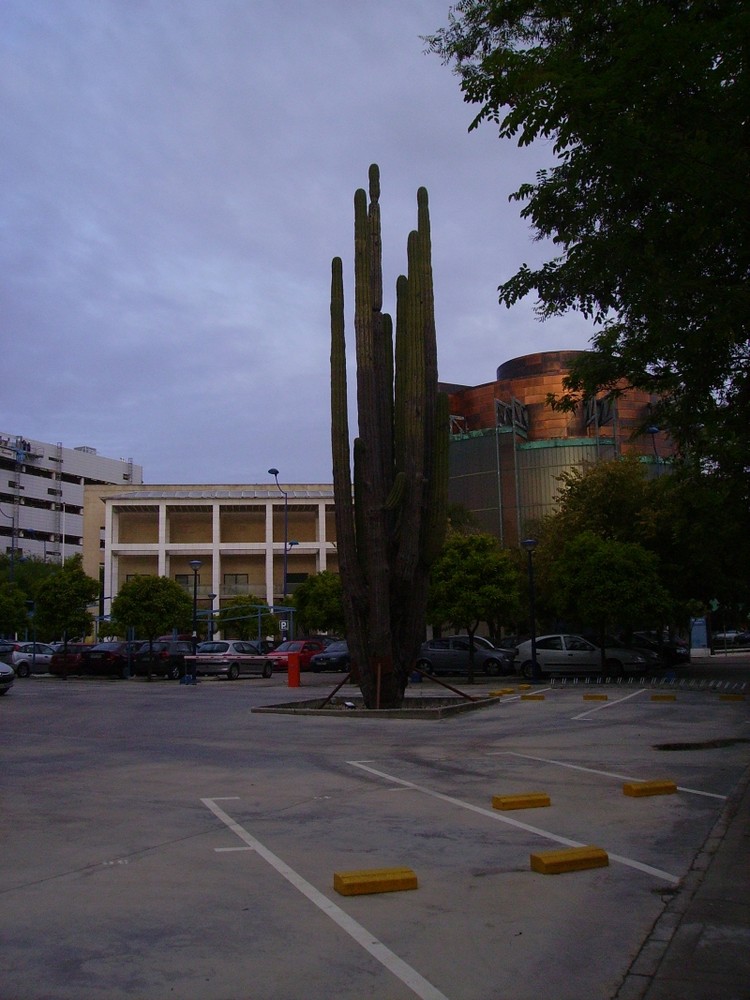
[84,484,338,617]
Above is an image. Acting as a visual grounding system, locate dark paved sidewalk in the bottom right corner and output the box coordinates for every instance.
[614,756,750,1000]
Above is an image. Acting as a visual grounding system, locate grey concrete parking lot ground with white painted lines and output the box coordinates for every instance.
[0,674,750,1000]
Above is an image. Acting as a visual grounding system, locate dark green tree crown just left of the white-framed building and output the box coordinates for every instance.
[35,555,99,645]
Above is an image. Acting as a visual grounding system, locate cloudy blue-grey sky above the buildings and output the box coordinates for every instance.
[0,0,592,484]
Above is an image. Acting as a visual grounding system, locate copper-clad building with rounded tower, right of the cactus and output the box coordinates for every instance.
[442,351,672,546]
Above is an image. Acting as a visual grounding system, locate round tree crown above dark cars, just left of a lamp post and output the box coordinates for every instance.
[112,576,193,642]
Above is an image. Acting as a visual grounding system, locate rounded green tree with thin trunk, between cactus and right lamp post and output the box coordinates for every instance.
[427,532,521,683]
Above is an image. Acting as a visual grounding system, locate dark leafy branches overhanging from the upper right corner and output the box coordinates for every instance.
[427,0,750,484]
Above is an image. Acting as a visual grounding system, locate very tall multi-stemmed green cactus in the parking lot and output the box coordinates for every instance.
[331,164,448,708]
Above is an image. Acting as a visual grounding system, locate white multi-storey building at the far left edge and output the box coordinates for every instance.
[0,433,143,576]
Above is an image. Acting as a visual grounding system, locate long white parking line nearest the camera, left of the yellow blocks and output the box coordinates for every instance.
[201,799,448,1000]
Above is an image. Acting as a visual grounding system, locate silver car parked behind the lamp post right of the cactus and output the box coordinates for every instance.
[517,634,648,678]
